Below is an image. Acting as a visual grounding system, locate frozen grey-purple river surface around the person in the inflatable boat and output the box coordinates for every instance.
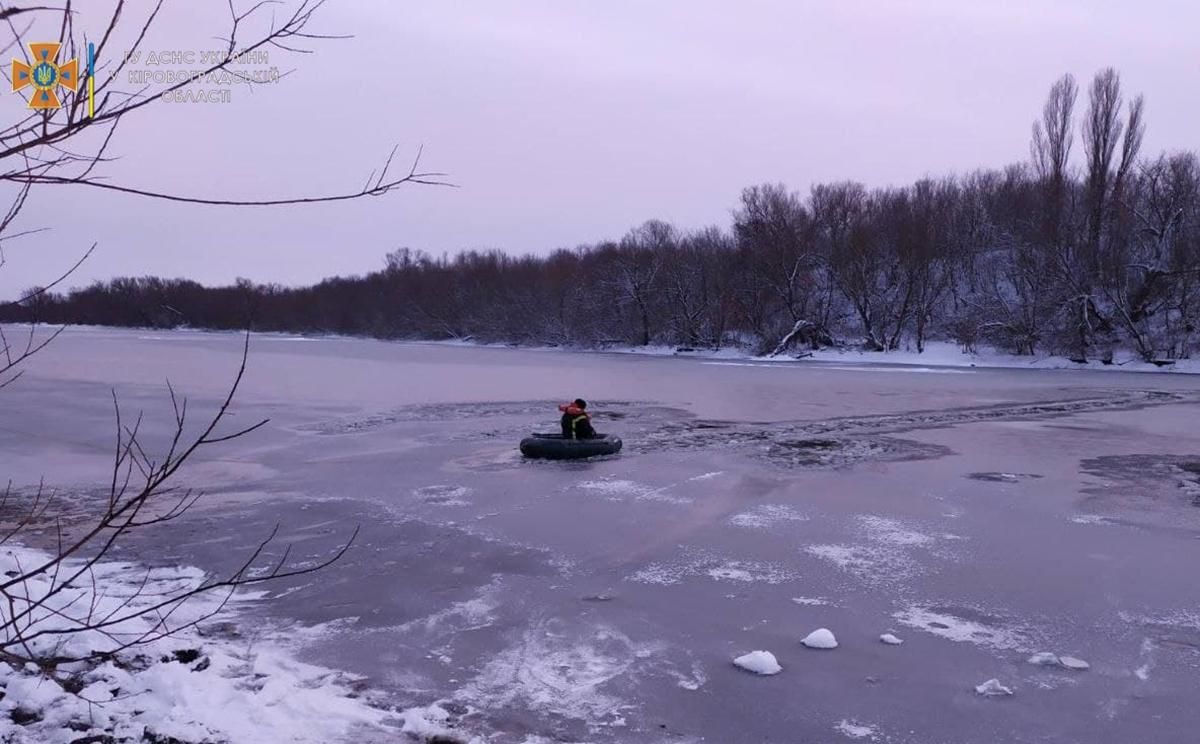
[0,330,1200,744]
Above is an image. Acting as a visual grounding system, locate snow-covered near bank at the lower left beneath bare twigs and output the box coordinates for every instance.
[0,545,468,744]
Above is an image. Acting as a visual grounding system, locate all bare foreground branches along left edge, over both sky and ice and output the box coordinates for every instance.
[0,0,444,681]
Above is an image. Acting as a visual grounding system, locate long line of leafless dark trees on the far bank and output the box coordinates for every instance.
[9,70,1200,360]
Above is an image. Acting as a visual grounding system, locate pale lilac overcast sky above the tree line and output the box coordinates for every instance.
[0,0,1200,296]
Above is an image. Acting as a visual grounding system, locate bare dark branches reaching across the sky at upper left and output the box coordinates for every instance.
[0,0,450,378]
